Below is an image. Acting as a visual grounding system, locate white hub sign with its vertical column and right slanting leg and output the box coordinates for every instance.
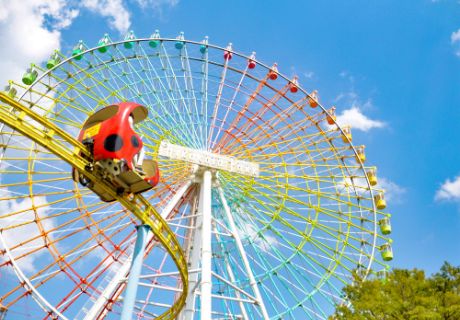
[158,141,269,320]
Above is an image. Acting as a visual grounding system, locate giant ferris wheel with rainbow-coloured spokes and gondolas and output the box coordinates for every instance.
[0,31,393,320]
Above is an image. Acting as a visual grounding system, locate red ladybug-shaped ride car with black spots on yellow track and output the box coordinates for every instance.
[72,102,160,202]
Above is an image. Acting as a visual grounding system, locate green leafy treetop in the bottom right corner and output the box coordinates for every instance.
[330,262,460,320]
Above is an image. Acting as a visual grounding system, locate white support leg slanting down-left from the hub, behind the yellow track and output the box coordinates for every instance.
[84,181,192,320]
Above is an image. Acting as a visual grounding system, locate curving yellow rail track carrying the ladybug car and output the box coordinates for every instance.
[0,92,188,319]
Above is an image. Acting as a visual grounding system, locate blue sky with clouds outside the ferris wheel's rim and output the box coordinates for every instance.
[0,0,460,273]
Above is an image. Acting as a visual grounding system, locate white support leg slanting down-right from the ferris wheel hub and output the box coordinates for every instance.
[218,187,270,320]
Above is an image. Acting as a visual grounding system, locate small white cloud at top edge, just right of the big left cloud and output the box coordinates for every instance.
[81,0,131,33]
